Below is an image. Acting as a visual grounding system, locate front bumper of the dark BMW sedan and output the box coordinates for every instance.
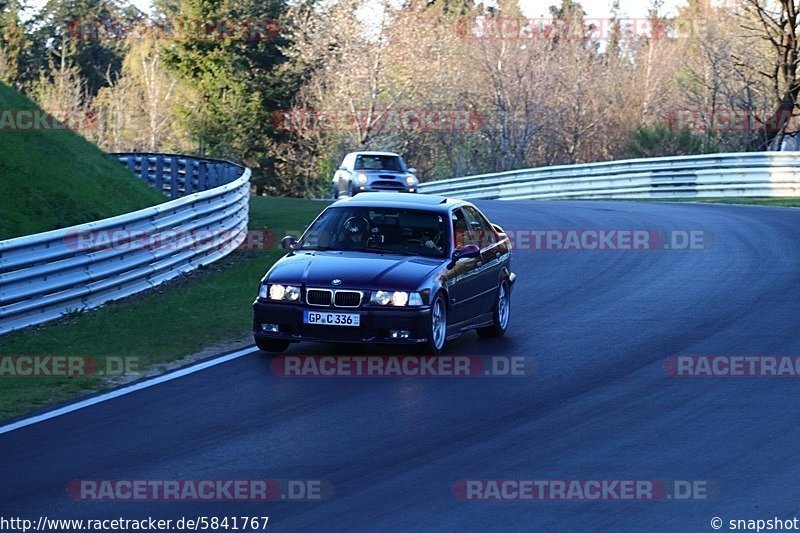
[253,300,431,344]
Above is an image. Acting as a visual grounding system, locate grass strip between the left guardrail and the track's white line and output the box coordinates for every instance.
[0,197,327,420]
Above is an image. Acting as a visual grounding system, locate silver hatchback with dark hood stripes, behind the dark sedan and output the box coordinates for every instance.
[331,152,419,199]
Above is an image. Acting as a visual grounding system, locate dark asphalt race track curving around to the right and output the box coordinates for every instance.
[0,202,800,531]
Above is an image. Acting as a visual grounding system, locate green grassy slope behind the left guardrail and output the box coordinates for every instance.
[0,83,166,240]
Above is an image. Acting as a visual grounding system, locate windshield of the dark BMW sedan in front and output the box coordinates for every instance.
[298,206,450,257]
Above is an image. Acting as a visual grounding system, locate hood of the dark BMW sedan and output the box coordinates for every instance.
[267,251,445,290]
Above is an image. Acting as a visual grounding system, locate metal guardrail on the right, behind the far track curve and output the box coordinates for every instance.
[419,152,800,200]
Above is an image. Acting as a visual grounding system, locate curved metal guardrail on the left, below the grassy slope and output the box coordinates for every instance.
[0,153,250,335]
